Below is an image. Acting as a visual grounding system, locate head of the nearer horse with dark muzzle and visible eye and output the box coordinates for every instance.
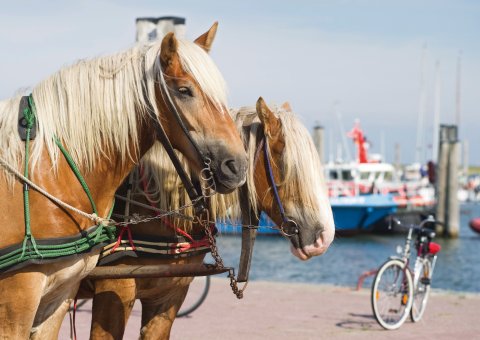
[154,23,247,193]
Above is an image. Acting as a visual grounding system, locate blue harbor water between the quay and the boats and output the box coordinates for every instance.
[212,203,480,292]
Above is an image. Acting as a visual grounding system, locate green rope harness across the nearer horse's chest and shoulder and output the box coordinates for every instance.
[0,95,115,272]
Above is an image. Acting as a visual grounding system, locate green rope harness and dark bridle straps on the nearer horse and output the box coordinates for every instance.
[0,58,213,273]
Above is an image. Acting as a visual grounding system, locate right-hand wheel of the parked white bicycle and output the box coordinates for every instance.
[410,258,432,322]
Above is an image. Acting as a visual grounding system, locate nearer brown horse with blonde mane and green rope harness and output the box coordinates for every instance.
[0,24,247,339]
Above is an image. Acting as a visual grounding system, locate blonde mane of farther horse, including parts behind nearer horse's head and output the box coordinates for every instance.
[136,103,328,229]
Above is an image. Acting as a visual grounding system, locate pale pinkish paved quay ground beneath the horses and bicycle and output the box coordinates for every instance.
[59,278,480,340]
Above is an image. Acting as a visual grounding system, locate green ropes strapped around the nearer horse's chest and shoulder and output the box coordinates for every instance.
[0,94,116,270]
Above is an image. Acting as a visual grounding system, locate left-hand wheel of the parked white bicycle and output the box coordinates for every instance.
[371,260,413,330]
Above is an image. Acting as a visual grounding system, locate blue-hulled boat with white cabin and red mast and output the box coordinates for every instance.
[217,122,434,236]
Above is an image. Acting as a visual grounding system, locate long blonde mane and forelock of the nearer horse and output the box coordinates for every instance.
[0,40,227,177]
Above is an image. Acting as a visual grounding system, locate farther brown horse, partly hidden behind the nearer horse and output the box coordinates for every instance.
[82,98,334,339]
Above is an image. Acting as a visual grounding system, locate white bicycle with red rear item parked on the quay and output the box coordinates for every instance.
[371,215,441,330]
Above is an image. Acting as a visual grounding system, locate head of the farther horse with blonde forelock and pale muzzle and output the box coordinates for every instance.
[254,97,335,260]
